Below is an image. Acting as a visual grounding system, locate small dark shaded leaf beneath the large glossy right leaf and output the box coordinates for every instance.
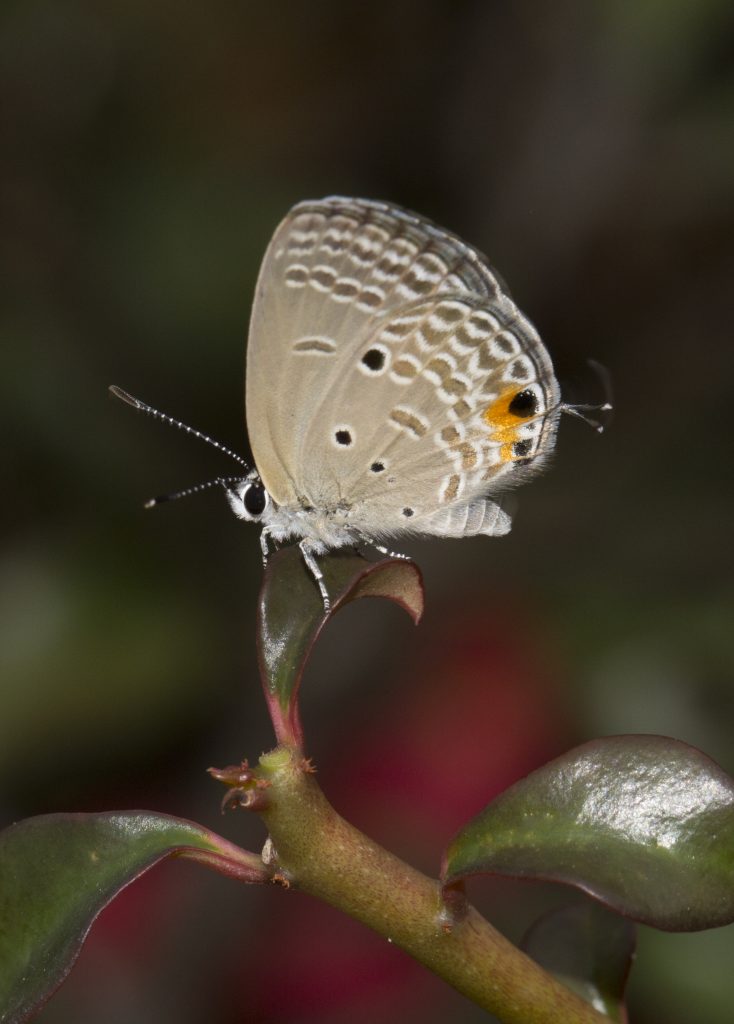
[521,900,635,1024]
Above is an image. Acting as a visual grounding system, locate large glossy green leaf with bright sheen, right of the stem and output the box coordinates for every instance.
[443,736,734,931]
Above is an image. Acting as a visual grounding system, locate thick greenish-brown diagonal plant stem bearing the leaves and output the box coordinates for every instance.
[260,746,609,1024]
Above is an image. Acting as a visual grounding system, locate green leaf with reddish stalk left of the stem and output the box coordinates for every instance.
[0,811,269,1024]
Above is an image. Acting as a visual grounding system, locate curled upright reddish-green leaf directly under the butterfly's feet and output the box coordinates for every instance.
[257,545,423,748]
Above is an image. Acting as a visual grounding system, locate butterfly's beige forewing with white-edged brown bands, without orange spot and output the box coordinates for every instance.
[247,198,500,504]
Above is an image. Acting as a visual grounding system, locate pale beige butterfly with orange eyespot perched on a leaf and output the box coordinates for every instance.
[112,197,607,610]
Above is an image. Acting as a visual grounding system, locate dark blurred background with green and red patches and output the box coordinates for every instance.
[0,0,734,1024]
